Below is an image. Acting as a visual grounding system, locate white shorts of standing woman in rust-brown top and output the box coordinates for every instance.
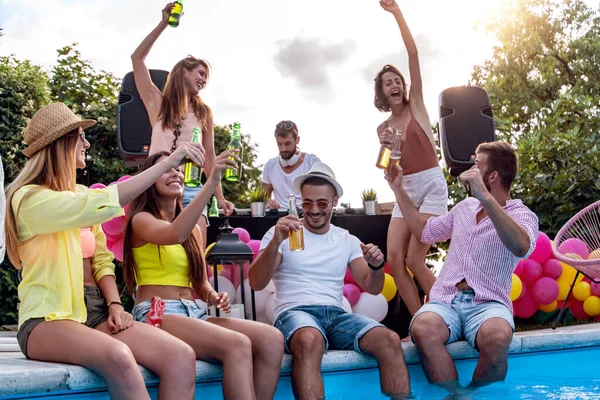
[392,167,448,218]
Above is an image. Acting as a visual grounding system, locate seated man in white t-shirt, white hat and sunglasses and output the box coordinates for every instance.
[248,162,410,399]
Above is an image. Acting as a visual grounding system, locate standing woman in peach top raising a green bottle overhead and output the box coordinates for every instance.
[131,3,234,246]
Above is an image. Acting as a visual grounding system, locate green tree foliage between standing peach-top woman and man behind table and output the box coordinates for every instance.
[215,125,262,208]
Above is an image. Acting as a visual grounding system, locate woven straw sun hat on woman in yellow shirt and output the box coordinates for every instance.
[23,103,96,157]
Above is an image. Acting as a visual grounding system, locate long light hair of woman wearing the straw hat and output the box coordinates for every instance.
[4,133,80,269]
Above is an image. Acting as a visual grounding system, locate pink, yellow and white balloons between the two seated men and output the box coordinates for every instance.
[344,263,397,322]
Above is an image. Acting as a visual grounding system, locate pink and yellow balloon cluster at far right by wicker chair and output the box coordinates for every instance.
[510,232,600,320]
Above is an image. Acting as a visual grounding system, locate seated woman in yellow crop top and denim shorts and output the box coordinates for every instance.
[123,150,283,399]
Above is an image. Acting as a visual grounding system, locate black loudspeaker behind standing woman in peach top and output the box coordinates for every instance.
[117,69,169,166]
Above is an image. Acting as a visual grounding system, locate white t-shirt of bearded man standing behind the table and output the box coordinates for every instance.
[262,153,321,210]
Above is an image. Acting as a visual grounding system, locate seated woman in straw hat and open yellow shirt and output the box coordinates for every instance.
[5,103,204,400]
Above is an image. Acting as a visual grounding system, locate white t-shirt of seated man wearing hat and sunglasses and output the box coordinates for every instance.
[260,225,363,318]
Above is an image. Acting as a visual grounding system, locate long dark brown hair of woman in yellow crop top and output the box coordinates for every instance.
[123,151,206,294]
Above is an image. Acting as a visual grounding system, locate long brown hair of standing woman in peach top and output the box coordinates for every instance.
[158,56,212,132]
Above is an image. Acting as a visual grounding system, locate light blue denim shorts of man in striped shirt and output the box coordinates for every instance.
[409,290,515,349]
